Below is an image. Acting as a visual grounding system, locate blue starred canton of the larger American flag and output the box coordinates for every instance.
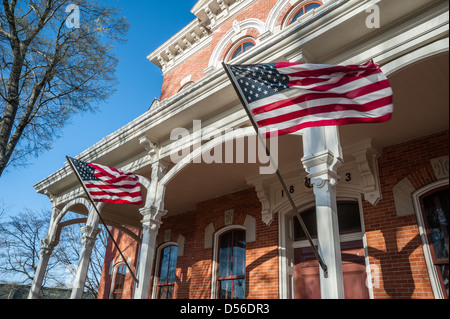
[230,63,289,103]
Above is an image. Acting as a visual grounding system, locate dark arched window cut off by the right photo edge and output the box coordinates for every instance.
[421,187,449,298]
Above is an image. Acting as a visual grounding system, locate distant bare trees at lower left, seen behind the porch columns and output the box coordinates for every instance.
[0,210,107,296]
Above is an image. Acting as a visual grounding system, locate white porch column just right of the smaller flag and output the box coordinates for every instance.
[134,161,168,299]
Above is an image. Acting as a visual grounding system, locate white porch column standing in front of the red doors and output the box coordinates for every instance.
[302,126,345,299]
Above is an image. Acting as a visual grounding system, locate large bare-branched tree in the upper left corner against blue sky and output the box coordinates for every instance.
[0,0,129,177]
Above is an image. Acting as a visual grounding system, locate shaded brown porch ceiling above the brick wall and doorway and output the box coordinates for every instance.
[165,53,449,219]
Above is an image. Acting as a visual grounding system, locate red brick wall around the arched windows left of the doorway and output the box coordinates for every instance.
[98,189,278,299]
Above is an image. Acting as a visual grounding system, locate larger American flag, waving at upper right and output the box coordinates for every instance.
[227,61,393,137]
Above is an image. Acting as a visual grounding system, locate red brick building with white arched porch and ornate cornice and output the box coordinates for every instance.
[30,0,449,299]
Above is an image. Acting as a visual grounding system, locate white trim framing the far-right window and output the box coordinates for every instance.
[412,178,449,299]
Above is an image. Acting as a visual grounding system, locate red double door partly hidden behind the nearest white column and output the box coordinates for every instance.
[294,241,369,299]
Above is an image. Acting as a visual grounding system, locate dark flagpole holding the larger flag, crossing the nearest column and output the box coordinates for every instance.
[222,62,328,278]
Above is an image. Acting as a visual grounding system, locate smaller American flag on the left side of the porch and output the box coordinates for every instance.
[68,157,143,205]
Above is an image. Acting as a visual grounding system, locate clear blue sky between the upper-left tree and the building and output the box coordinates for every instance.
[0,0,197,215]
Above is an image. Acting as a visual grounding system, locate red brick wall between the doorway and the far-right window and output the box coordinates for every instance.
[363,131,449,299]
